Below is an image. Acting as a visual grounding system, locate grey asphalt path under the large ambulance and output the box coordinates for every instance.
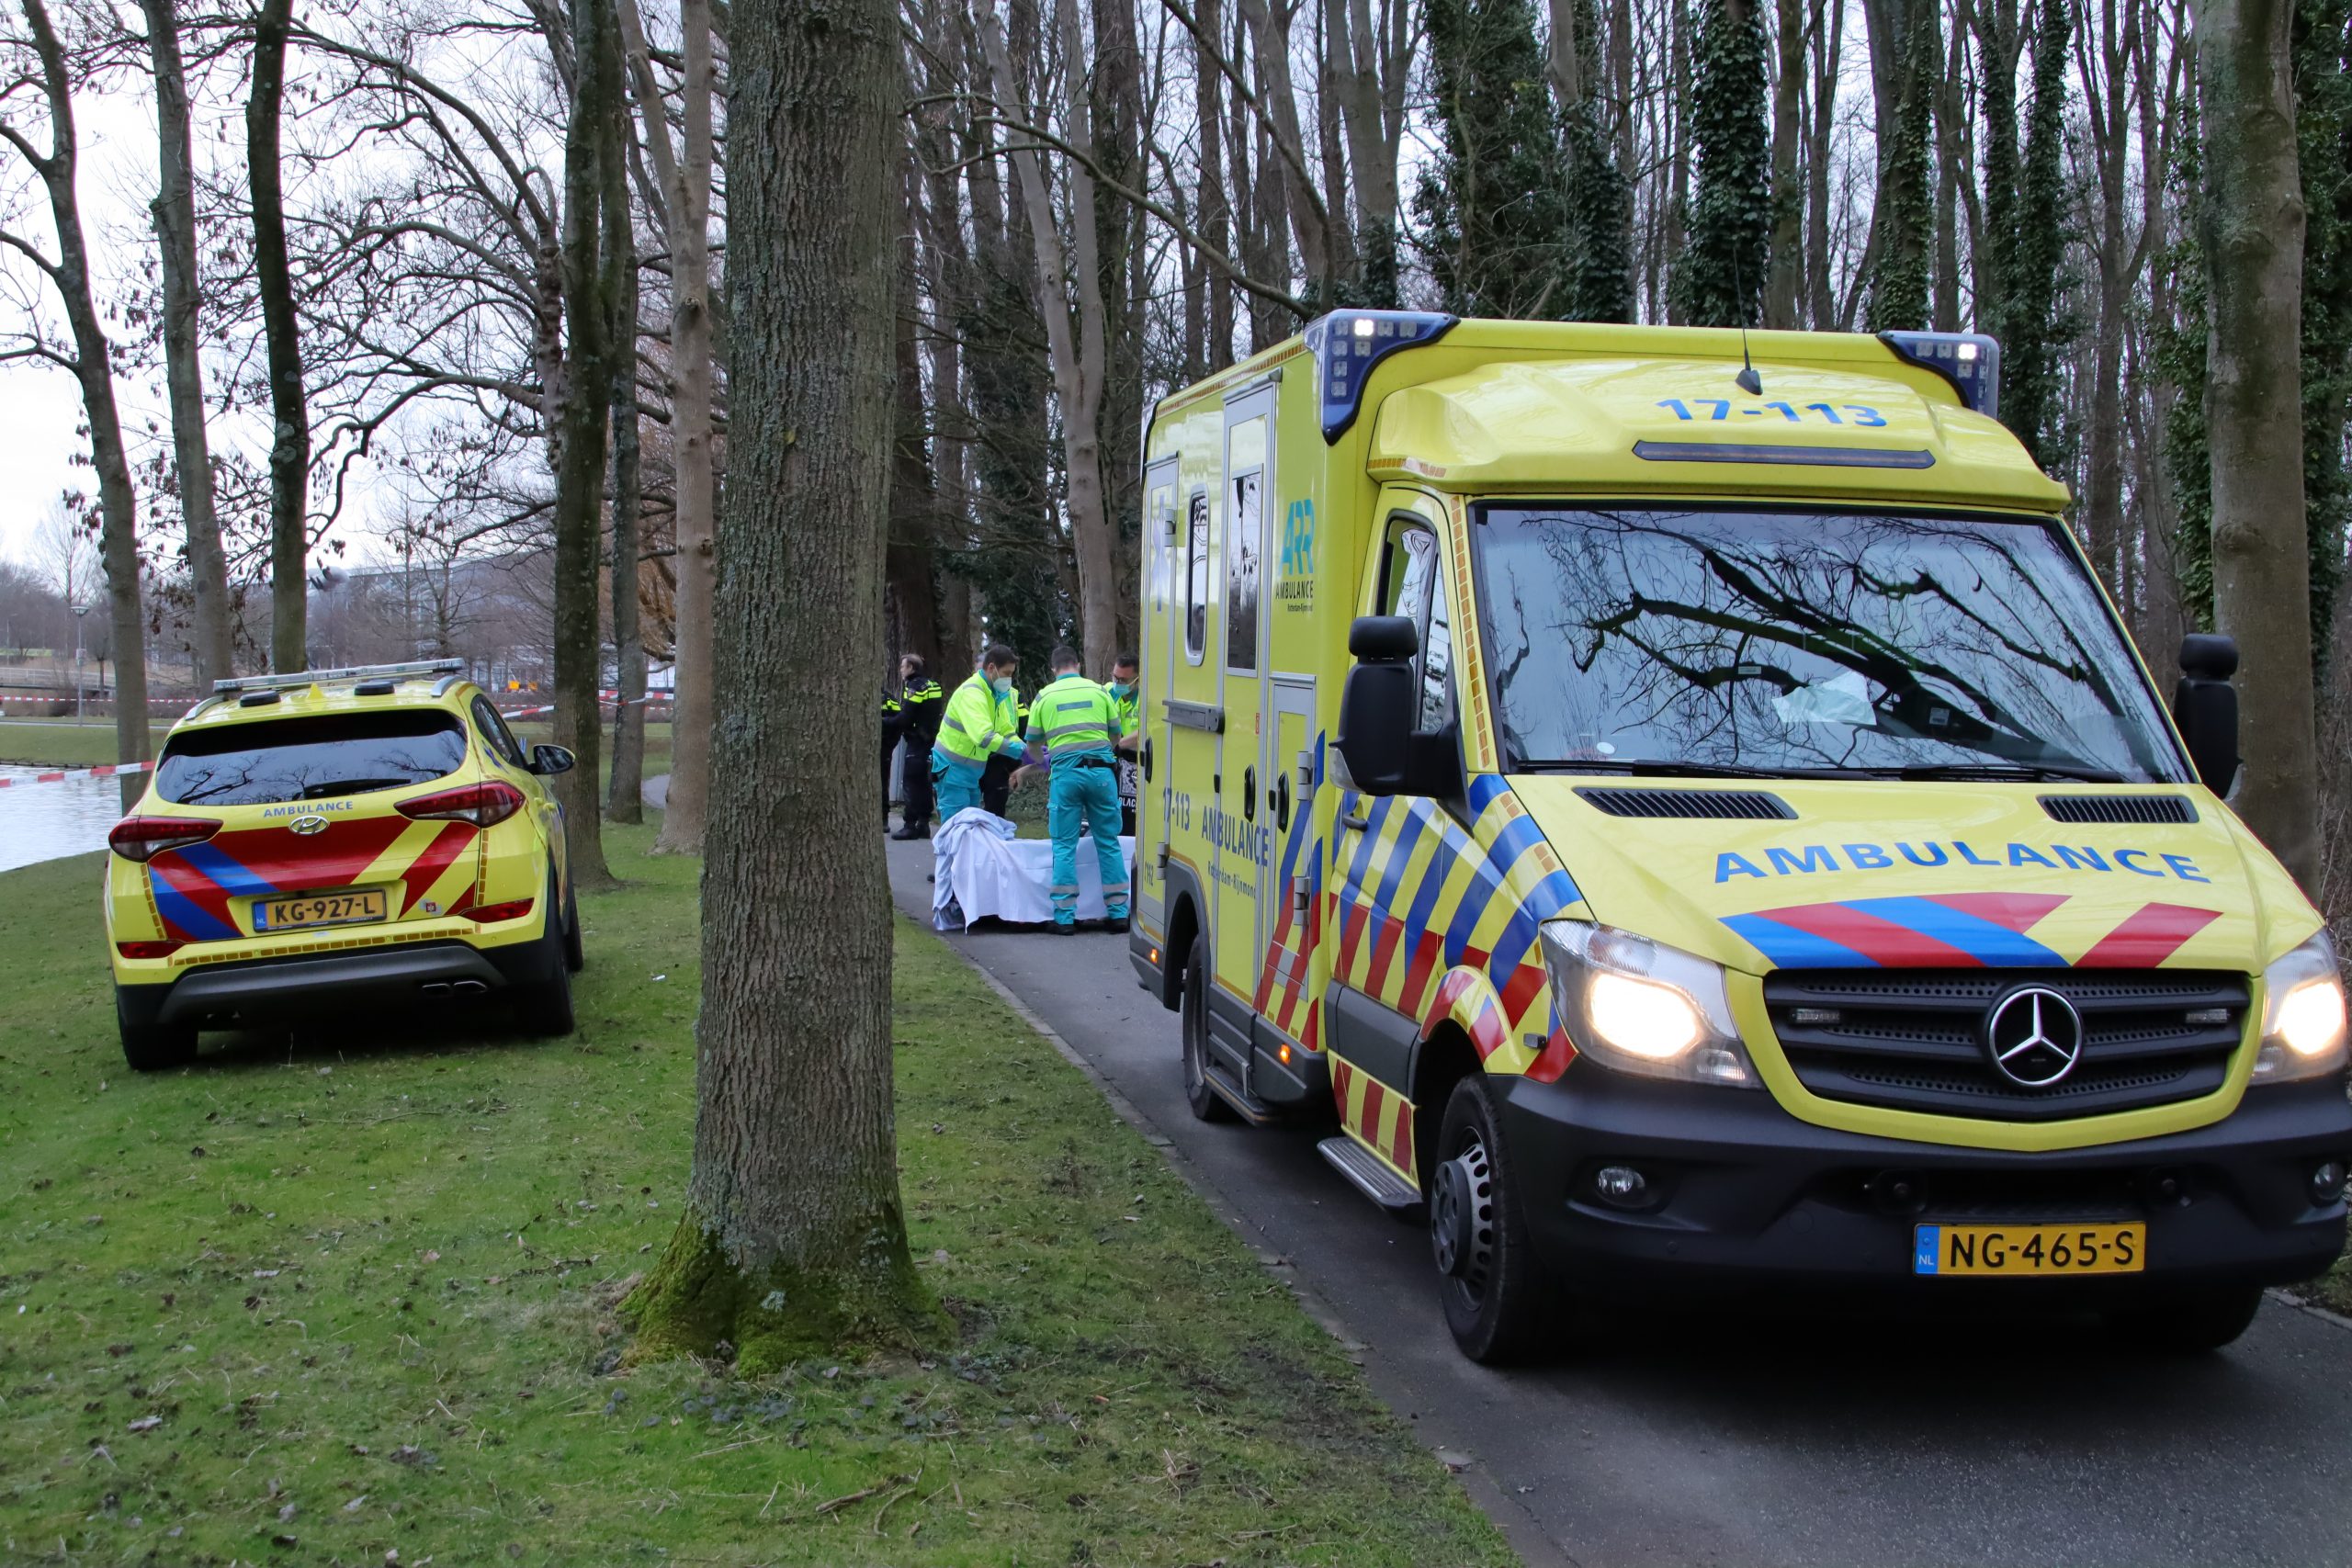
[889,844,2352,1568]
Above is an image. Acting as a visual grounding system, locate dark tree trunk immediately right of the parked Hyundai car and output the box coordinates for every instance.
[555,0,630,888]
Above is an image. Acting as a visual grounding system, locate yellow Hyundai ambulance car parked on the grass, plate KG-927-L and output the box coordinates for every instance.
[106,660,583,1069]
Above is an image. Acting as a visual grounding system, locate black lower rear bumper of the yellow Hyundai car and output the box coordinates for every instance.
[120,941,562,1030]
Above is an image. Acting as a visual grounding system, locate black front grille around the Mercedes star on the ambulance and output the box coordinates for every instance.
[1764,968,2248,1122]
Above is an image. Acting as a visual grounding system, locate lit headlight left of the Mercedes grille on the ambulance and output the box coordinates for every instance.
[1543,919,1761,1089]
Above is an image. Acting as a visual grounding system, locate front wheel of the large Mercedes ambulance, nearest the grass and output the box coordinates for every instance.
[1428,1072,1553,1363]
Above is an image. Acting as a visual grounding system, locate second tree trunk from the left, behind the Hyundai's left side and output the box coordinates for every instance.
[139,0,235,691]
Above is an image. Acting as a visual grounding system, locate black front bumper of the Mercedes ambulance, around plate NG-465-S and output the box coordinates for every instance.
[1503,1063,2352,1307]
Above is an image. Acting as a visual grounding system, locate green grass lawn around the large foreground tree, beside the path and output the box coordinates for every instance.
[0,828,1510,1568]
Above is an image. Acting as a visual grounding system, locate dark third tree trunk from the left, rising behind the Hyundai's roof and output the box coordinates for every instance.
[244,0,311,674]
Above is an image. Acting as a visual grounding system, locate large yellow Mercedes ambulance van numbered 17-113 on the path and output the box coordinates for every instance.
[1131,310,2352,1359]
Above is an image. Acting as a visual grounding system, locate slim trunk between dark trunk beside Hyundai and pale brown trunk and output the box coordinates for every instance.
[605,138,644,823]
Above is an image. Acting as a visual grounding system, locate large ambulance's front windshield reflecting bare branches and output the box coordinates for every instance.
[1475,503,2185,783]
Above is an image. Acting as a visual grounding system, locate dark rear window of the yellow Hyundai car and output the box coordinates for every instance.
[155,707,466,807]
